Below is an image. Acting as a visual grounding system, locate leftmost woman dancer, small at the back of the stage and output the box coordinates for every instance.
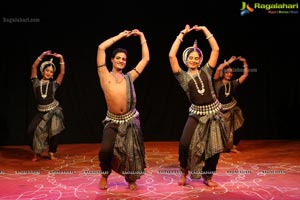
[28,50,65,161]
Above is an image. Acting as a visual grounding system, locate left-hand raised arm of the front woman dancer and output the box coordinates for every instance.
[169,24,191,73]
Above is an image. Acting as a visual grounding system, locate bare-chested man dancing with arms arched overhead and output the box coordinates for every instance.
[97,29,150,190]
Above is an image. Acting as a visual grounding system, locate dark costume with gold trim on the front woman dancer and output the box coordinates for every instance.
[175,63,228,179]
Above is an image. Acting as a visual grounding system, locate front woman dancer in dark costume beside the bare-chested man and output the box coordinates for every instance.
[169,25,228,187]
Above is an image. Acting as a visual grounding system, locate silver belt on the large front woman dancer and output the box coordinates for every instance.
[189,100,222,115]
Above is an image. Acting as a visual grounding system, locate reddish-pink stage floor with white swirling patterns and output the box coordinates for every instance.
[0,140,300,200]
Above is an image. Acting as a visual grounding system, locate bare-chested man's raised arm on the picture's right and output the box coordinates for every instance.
[129,29,150,80]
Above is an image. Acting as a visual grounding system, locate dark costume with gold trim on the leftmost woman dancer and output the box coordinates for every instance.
[28,78,65,154]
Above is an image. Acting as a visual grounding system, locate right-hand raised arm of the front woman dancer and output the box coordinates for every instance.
[192,25,220,68]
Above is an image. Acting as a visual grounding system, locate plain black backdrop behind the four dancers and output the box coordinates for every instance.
[0,1,300,145]
